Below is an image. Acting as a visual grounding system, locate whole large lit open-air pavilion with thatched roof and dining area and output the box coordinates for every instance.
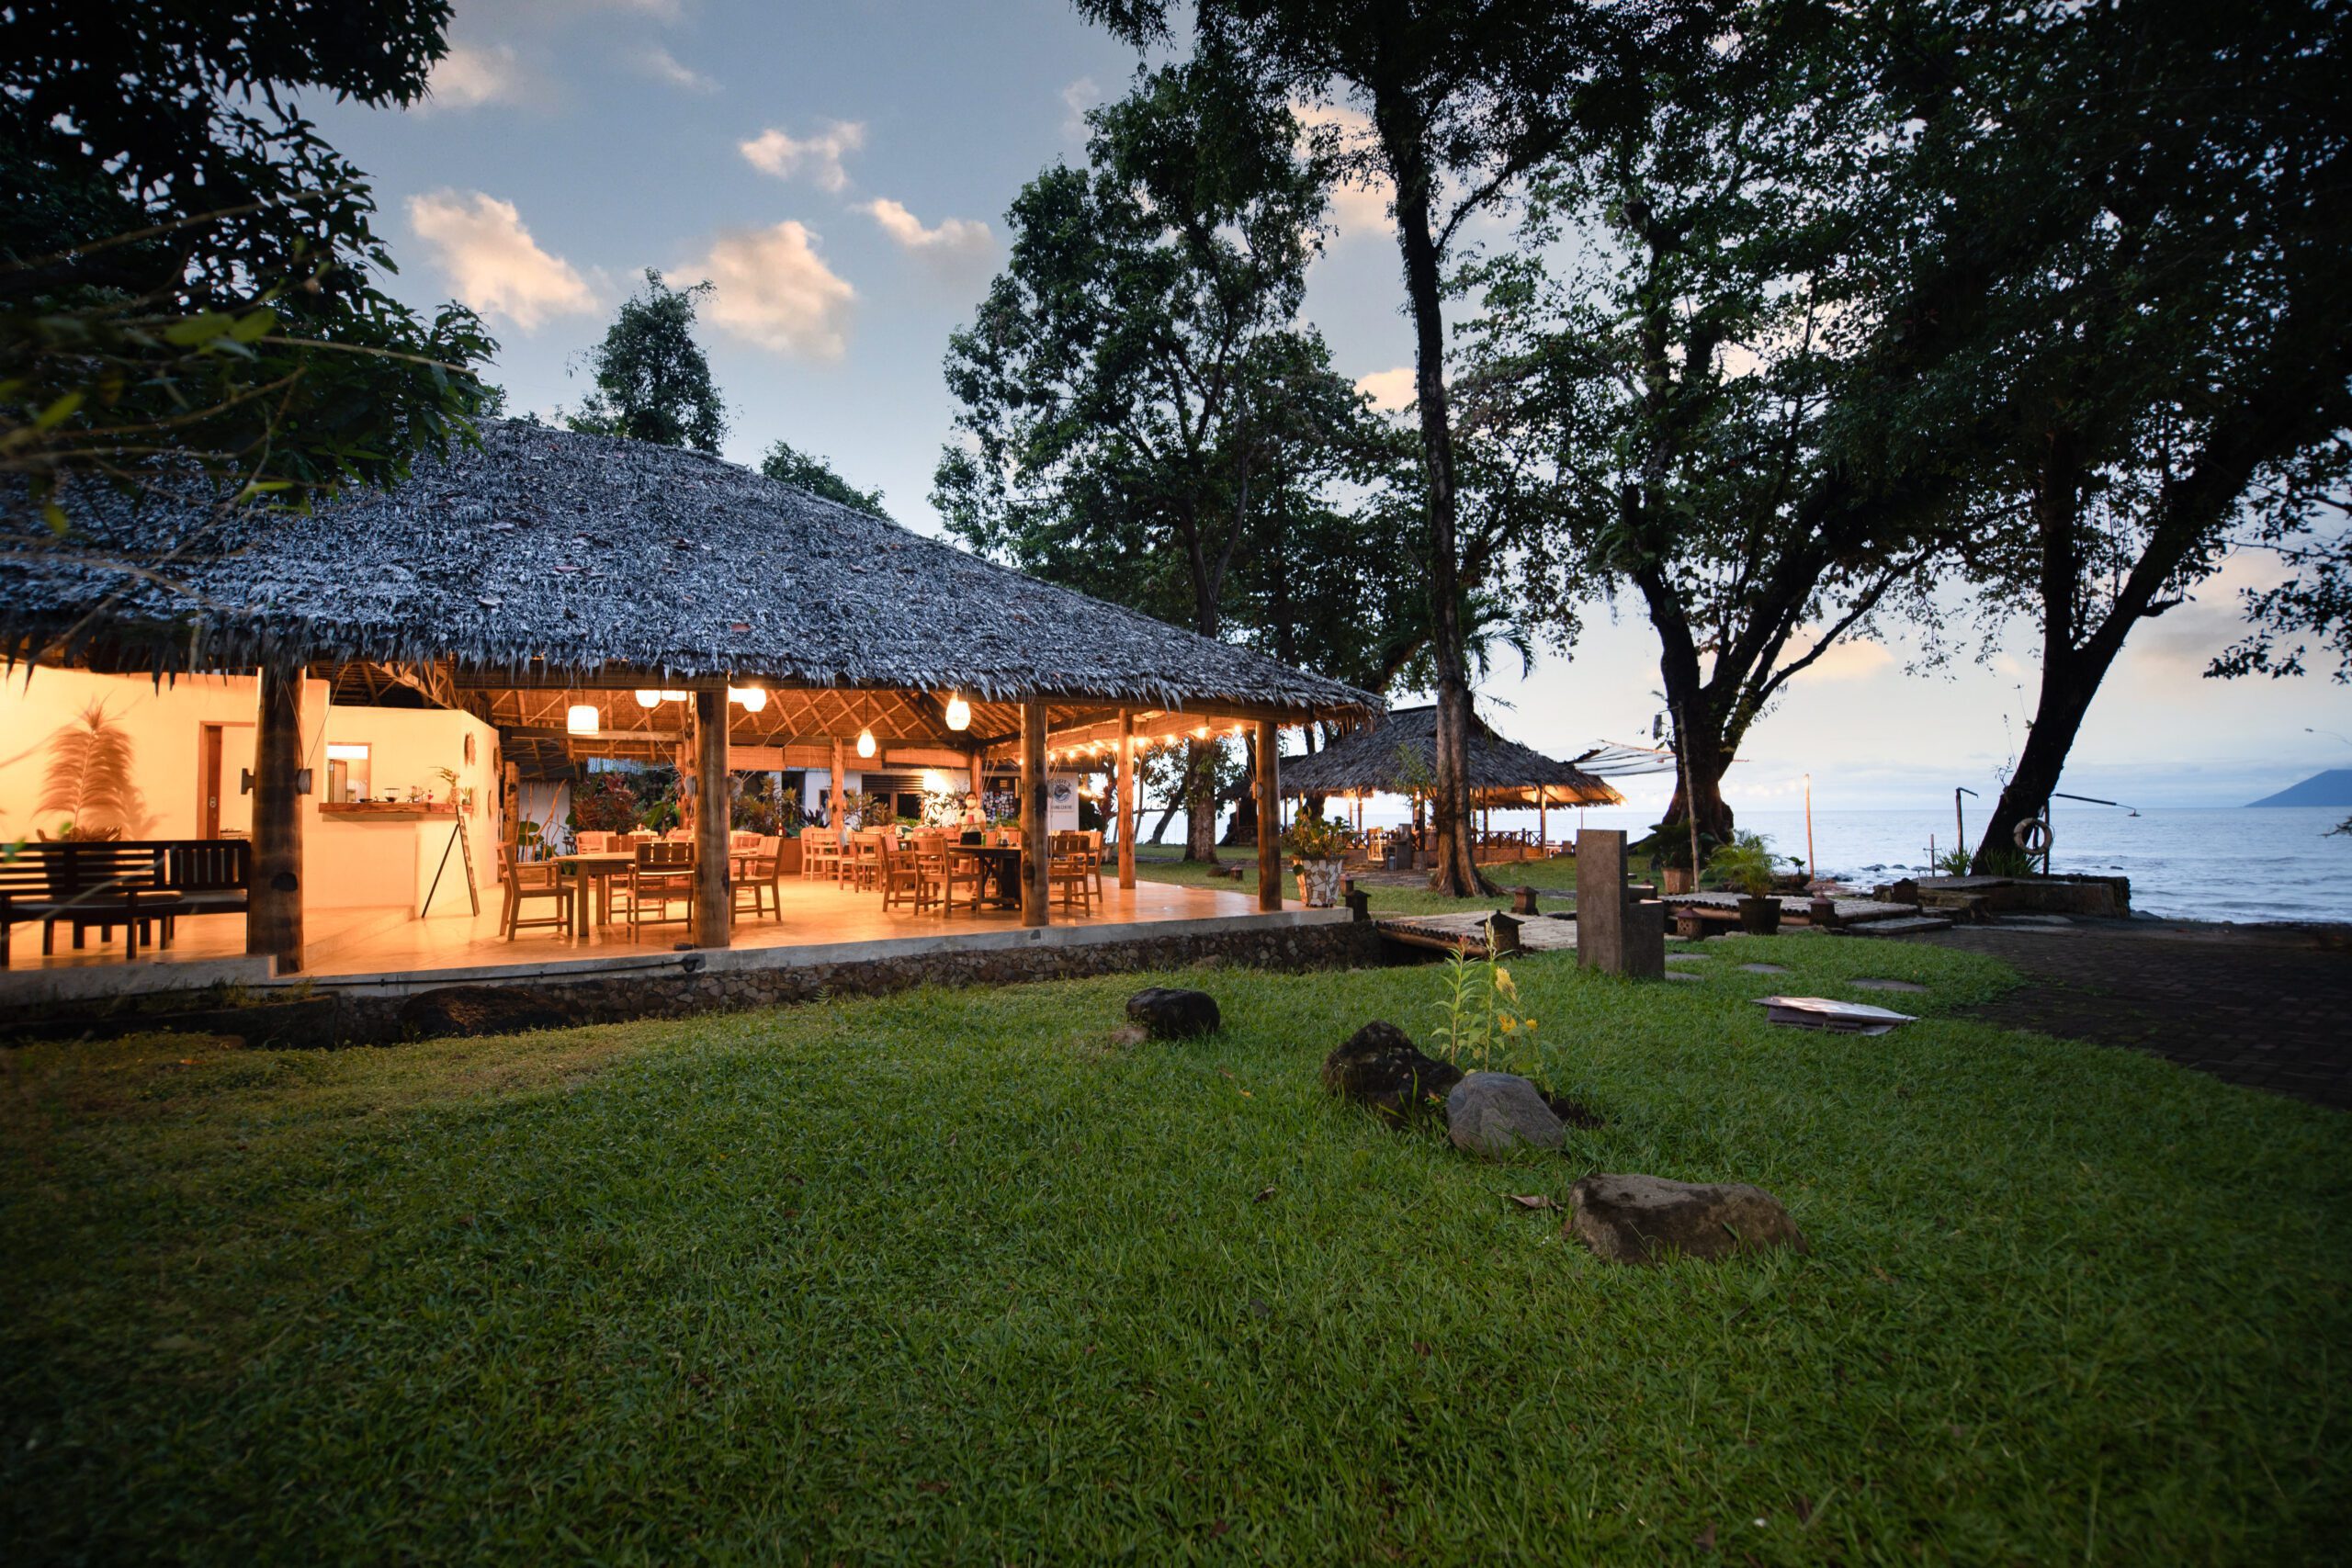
[0,421,1378,1001]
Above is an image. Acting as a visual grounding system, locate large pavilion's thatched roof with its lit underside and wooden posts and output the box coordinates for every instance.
[0,421,1378,968]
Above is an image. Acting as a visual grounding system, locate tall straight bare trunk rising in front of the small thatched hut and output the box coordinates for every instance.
[1374,116,1494,898]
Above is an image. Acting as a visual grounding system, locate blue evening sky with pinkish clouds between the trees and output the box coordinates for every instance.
[303,0,2352,808]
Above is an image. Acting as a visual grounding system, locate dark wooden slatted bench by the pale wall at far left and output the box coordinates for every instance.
[0,840,254,964]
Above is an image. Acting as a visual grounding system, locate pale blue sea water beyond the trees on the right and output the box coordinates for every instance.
[1543,802,2352,921]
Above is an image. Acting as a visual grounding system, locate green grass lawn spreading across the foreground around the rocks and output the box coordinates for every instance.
[0,936,2352,1563]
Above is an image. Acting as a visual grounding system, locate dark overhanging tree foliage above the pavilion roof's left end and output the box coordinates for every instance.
[0,0,496,550]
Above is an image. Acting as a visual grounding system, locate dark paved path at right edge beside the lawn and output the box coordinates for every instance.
[1912,921,2352,1110]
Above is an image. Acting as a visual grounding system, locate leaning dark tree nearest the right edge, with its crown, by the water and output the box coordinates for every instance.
[1903,0,2352,865]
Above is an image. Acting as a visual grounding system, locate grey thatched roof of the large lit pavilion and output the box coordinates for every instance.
[0,421,1378,717]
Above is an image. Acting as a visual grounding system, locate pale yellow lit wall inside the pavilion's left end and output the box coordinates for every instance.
[0,668,499,912]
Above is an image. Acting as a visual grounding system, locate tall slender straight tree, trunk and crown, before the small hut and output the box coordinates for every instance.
[1080,0,1710,894]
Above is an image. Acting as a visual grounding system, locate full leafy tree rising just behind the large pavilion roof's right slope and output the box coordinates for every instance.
[933,51,1362,861]
